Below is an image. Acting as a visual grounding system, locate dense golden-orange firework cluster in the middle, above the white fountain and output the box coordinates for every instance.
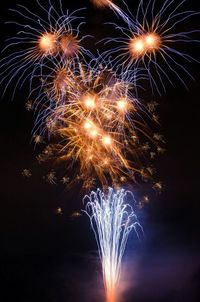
[36,66,156,186]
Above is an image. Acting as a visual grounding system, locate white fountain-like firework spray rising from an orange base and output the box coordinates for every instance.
[83,188,142,302]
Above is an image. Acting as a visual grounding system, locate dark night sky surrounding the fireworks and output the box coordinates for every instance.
[0,0,200,302]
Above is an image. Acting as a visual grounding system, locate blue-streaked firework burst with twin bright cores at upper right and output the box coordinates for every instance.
[104,0,199,94]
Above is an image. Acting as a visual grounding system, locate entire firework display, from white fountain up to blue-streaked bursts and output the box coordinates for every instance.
[0,0,199,302]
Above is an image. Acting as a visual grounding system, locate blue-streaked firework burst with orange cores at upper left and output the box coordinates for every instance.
[0,1,91,96]
